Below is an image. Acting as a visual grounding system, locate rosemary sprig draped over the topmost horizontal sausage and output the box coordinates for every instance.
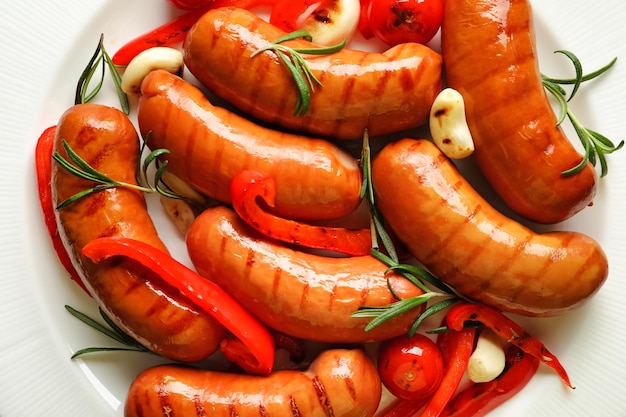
[250,29,346,117]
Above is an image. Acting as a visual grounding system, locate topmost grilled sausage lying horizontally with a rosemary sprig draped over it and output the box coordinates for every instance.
[184,8,442,139]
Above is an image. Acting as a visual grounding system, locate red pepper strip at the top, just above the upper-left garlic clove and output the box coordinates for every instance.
[111,0,275,66]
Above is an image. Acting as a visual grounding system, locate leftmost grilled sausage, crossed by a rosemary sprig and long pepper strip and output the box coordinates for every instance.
[52,104,226,362]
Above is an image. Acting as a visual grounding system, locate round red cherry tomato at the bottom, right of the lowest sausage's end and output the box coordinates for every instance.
[378,333,443,400]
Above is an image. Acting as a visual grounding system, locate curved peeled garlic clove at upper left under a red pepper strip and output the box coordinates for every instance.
[122,46,184,95]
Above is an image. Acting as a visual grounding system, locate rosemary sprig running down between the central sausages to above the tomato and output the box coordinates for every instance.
[351,131,461,337]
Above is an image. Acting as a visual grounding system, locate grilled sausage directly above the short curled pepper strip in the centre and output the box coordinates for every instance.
[138,70,361,220]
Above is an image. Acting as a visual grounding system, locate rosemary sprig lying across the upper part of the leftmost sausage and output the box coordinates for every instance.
[52,139,183,210]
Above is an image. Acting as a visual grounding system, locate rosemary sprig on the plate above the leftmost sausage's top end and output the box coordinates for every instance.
[74,34,130,114]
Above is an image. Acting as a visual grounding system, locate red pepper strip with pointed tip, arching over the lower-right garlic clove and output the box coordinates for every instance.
[446,303,574,389]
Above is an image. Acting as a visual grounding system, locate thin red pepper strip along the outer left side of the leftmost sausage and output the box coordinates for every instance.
[35,126,90,295]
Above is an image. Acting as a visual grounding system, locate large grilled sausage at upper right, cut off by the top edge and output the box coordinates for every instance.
[442,0,597,223]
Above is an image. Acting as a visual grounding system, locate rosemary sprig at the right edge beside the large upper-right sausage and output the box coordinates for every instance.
[542,50,624,177]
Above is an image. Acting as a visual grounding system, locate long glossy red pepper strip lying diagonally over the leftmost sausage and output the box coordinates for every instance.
[82,237,274,375]
